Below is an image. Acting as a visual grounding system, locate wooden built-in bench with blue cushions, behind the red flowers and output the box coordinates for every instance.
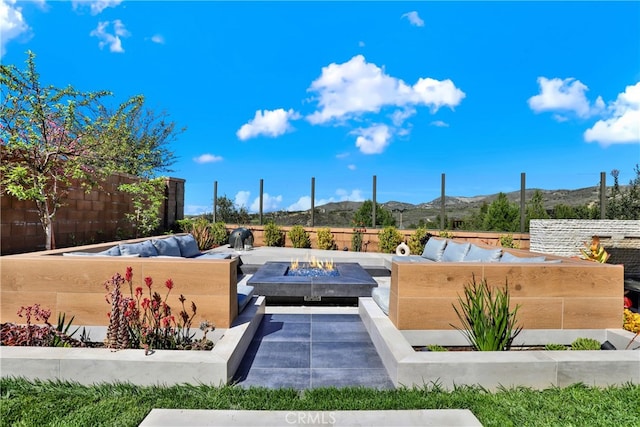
[0,234,253,328]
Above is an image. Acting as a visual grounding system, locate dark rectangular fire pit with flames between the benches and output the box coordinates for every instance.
[247,261,378,301]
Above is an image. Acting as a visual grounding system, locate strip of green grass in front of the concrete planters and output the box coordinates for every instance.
[0,378,640,426]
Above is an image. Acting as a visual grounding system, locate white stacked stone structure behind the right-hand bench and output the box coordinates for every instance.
[529,219,640,275]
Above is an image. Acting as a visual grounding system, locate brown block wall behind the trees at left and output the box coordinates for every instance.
[0,174,184,255]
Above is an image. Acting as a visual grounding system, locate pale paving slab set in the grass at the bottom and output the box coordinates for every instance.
[140,409,482,427]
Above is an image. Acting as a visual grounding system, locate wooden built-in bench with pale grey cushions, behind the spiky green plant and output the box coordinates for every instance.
[372,238,624,330]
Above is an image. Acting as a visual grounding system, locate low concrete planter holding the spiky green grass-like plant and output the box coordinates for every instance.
[359,298,640,390]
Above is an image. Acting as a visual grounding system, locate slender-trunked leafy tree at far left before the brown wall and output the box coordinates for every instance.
[0,52,109,249]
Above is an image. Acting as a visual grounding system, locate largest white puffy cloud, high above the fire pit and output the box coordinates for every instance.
[307,55,465,124]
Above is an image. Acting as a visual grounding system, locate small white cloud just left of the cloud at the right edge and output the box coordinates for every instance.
[528,77,604,118]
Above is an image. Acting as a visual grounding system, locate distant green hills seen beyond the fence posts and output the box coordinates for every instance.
[266,187,599,227]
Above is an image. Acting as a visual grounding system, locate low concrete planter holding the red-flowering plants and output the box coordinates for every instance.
[0,297,265,386]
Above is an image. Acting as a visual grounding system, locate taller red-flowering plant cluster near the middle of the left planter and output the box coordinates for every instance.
[105,267,213,352]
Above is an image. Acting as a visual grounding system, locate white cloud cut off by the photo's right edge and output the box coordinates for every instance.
[584,82,640,146]
